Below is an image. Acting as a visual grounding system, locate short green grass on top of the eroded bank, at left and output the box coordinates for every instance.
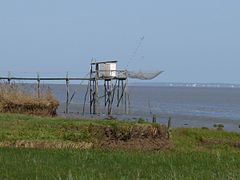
[0,114,138,142]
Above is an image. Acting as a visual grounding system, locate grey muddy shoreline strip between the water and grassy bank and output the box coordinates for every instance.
[58,113,240,132]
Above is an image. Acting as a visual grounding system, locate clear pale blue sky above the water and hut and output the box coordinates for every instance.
[0,0,240,83]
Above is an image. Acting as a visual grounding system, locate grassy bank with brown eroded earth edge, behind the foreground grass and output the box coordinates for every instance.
[0,114,169,150]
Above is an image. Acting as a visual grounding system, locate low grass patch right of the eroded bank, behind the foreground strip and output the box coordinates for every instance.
[171,128,240,152]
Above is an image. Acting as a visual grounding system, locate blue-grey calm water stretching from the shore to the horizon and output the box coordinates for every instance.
[34,85,240,131]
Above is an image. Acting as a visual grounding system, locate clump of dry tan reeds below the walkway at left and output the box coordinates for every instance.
[0,84,59,116]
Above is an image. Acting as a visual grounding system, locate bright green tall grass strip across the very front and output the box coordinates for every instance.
[0,148,240,179]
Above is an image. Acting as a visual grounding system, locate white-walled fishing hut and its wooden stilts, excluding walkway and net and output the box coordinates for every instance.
[84,60,129,116]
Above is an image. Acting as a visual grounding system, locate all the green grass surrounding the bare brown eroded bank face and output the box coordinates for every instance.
[0,114,240,179]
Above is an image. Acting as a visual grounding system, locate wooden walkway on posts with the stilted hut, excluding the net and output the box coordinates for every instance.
[0,61,129,116]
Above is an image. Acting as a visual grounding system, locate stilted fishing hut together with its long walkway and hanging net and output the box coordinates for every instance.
[0,60,163,116]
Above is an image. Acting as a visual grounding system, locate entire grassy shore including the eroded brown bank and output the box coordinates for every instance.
[0,114,240,179]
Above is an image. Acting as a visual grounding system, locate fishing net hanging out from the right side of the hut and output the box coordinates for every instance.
[128,71,163,80]
